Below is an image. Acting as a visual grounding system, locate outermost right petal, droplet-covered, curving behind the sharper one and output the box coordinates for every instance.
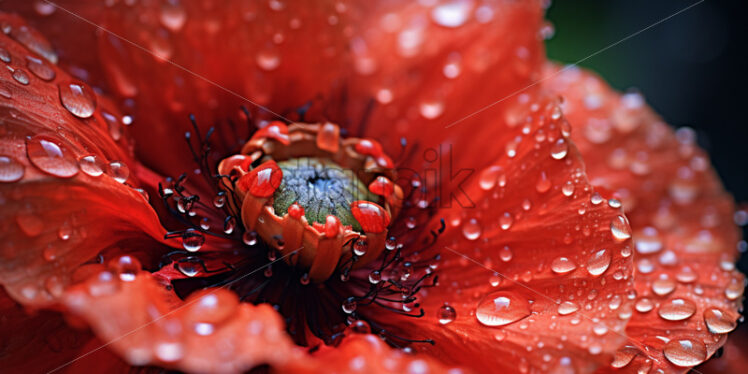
[546,66,744,372]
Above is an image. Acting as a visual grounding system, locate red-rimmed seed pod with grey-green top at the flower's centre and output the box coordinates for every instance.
[218,121,402,282]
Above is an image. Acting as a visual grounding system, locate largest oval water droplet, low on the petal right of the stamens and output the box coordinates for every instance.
[475,291,530,326]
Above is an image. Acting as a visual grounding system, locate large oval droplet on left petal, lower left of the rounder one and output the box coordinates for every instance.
[26,135,78,178]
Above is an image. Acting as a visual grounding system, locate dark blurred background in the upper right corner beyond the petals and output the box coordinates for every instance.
[546,0,748,273]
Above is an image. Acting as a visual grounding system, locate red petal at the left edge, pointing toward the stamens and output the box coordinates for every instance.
[0,19,171,306]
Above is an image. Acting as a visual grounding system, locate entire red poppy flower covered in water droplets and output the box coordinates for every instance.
[0,0,743,373]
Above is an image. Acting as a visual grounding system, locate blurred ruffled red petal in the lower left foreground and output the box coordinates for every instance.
[64,272,304,373]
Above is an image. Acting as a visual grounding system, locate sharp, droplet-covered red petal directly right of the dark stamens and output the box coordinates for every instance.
[362,95,633,372]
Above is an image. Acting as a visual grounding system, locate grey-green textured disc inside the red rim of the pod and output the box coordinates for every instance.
[273,157,378,232]
